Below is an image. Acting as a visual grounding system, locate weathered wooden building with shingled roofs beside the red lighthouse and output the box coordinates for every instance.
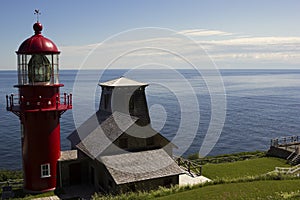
[58,77,183,193]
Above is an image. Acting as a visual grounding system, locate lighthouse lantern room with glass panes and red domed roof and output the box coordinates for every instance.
[16,22,60,86]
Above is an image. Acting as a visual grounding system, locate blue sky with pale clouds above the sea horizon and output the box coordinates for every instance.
[0,0,300,70]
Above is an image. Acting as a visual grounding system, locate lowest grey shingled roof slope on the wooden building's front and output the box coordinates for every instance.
[100,149,184,184]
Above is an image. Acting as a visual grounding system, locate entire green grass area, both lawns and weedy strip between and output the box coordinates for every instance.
[94,157,300,200]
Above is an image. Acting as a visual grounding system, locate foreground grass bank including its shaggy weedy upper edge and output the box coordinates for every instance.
[94,176,300,200]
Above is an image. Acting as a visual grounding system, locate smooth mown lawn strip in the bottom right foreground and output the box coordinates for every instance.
[156,179,300,200]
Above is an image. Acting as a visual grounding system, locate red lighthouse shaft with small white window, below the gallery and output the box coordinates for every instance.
[22,111,60,193]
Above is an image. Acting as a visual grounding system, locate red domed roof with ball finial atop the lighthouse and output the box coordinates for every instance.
[16,22,60,54]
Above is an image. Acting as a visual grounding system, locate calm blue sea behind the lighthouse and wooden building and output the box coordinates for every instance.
[0,70,300,169]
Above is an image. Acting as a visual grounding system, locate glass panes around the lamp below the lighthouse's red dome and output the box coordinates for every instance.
[18,54,59,85]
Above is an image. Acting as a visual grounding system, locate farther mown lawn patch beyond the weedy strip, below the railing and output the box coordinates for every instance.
[202,157,290,180]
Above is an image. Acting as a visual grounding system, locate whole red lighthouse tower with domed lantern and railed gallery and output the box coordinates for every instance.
[6,16,72,193]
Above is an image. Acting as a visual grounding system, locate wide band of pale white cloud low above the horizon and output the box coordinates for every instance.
[61,29,300,68]
